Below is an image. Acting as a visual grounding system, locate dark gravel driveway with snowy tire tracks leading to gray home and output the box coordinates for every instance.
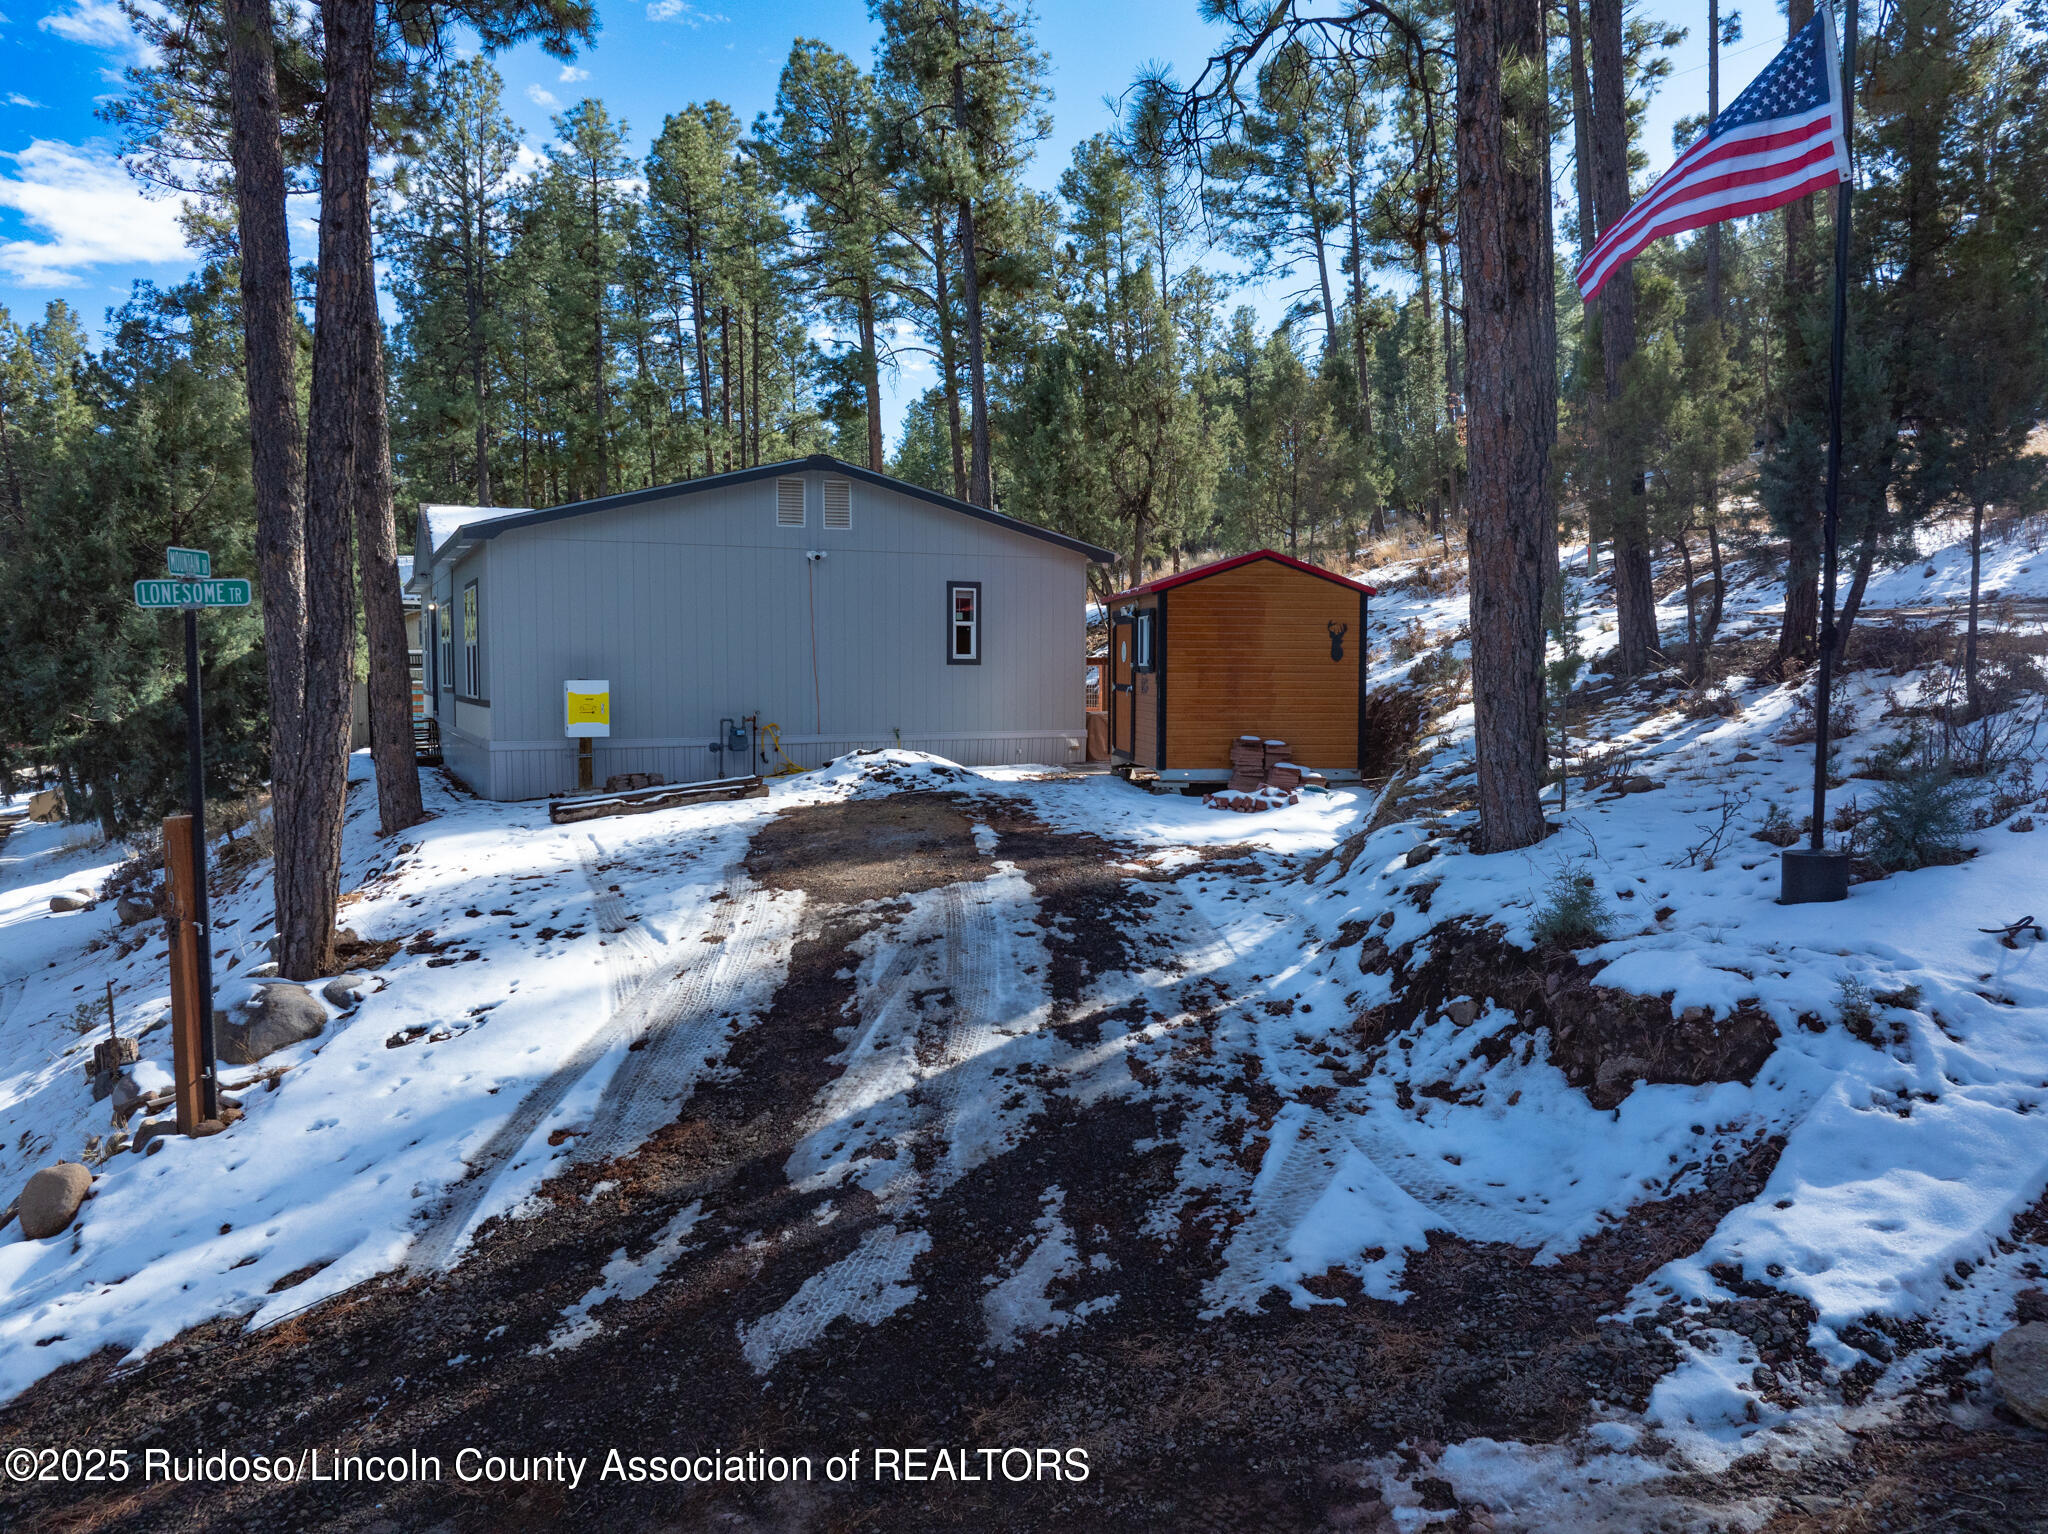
[0,791,2021,1534]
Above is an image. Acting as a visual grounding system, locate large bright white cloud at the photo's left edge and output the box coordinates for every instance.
[0,139,190,287]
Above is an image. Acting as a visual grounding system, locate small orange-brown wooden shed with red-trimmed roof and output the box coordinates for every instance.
[1110,549,1374,782]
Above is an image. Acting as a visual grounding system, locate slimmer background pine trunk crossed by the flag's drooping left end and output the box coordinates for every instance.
[1589,0,1657,676]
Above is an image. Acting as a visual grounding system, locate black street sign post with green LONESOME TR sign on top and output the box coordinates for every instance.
[135,549,250,1131]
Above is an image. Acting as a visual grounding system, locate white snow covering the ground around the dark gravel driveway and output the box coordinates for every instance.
[0,528,2048,1528]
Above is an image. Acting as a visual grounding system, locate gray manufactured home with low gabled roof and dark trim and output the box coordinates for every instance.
[410,457,1112,799]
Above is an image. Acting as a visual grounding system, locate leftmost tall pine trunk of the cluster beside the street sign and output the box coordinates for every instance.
[225,0,319,979]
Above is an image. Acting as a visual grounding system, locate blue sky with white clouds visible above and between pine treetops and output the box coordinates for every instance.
[0,0,1784,436]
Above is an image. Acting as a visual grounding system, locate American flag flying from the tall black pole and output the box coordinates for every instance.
[1577,4,1849,301]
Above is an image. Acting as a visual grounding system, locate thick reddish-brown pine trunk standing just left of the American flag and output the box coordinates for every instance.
[1446,0,1556,852]
